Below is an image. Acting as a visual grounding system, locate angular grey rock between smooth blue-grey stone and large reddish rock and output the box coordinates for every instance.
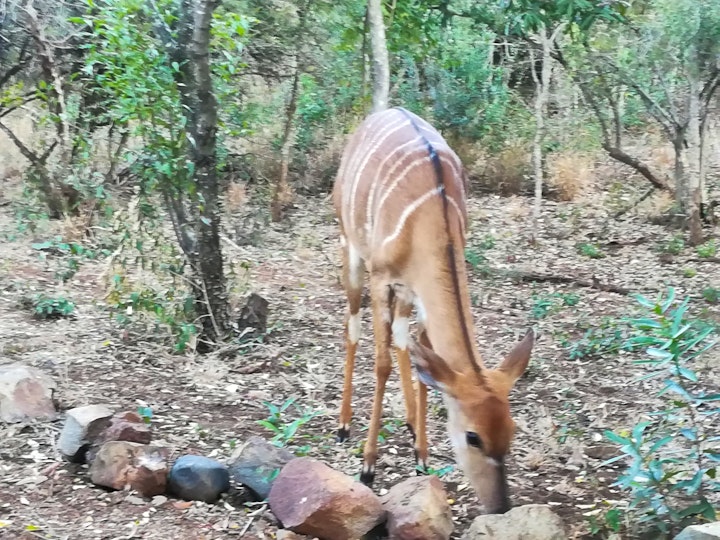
[229,437,295,500]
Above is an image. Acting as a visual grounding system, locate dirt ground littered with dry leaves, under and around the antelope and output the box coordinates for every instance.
[0,178,720,540]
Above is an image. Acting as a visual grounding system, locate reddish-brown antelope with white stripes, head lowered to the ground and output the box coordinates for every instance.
[333,108,535,513]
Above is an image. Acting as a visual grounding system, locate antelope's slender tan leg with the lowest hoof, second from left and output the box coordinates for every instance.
[360,275,393,486]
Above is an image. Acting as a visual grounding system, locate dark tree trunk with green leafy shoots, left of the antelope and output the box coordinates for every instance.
[190,0,230,348]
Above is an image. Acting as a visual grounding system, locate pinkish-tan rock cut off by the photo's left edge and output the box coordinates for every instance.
[0,364,57,423]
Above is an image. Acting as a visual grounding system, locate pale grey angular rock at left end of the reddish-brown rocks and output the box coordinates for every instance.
[58,405,112,463]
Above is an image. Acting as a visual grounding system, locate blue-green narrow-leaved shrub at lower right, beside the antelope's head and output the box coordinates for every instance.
[605,288,720,537]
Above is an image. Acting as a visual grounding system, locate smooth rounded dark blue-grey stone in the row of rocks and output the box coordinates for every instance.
[168,456,230,503]
